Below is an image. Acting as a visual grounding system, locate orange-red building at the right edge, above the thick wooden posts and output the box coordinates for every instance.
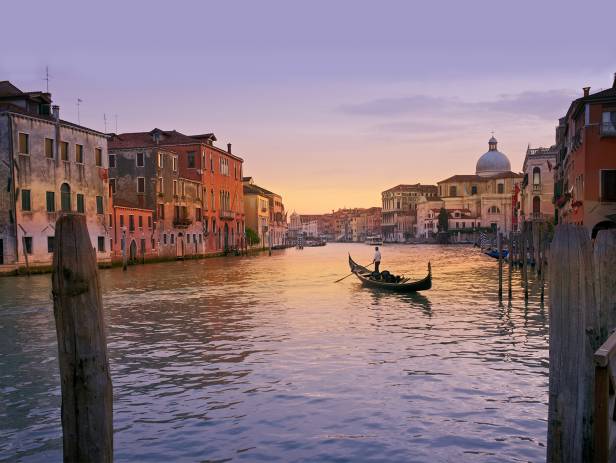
[554,75,616,237]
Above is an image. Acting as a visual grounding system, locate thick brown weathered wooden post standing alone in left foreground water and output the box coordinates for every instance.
[52,215,113,462]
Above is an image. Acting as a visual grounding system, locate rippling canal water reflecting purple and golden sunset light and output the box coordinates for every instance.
[0,244,548,462]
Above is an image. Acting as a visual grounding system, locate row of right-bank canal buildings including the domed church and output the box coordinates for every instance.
[289,75,616,242]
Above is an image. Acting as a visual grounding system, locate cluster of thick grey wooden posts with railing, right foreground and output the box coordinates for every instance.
[548,224,616,463]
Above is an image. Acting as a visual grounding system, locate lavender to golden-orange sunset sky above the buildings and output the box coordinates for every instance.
[0,0,616,213]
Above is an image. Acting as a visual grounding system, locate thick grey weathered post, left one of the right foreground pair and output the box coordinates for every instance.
[547,224,598,463]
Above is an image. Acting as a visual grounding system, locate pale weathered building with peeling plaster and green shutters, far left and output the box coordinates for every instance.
[0,81,111,267]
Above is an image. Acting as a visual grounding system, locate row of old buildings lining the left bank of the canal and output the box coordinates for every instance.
[0,81,287,273]
